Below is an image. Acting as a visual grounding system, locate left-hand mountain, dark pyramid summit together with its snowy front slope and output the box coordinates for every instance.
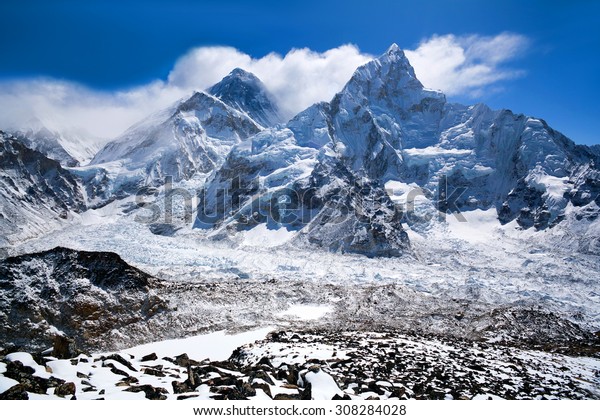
[91,69,279,185]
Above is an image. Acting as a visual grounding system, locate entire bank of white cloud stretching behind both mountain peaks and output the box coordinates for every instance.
[0,33,527,138]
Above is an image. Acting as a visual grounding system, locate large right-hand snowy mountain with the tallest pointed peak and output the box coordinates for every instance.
[196,45,600,255]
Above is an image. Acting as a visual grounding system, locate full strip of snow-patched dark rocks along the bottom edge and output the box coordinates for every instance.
[0,331,600,400]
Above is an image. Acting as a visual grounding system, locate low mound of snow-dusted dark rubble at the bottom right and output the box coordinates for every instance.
[232,331,600,399]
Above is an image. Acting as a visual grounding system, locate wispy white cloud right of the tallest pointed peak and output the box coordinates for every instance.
[406,33,529,97]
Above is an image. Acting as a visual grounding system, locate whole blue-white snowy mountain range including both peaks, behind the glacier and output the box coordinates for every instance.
[3,45,600,256]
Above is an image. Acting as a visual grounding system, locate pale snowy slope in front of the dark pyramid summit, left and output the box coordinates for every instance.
[91,92,260,184]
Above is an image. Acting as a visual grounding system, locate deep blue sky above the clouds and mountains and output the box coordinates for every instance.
[0,0,600,144]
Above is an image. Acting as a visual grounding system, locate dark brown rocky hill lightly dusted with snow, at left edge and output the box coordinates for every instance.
[0,248,166,357]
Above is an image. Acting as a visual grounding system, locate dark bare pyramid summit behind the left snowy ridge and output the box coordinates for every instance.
[208,68,282,127]
